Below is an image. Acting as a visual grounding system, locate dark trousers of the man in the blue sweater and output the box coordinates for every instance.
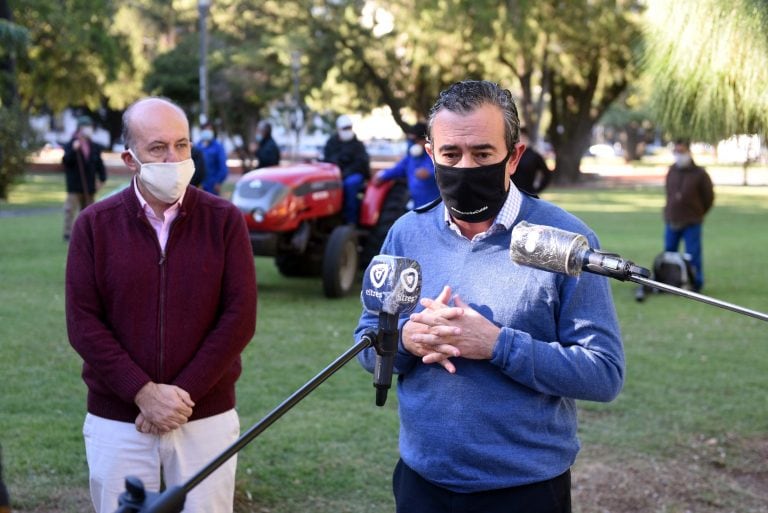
[392,460,571,513]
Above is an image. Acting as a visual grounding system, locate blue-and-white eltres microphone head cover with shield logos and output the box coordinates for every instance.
[360,255,421,315]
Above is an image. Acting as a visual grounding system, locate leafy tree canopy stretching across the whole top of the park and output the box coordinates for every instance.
[6,0,768,194]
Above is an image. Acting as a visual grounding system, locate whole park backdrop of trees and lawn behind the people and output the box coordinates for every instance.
[0,0,768,513]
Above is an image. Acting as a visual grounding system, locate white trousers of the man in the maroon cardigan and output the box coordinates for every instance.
[83,409,240,513]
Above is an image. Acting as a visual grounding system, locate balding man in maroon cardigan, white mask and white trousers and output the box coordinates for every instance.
[66,98,256,513]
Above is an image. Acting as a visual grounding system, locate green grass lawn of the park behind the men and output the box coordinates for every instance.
[0,176,768,513]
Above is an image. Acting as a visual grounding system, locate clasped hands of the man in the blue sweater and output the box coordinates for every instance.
[402,285,501,374]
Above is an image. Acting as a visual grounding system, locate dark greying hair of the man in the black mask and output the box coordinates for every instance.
[427,80,520,151]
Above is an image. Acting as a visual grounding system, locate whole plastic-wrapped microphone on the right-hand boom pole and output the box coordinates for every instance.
[509,221,651,281]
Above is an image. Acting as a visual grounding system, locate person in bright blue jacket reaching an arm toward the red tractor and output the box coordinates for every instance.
[373,123,440,207]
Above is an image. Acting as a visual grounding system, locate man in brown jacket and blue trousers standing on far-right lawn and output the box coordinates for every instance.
[664,139,715,292]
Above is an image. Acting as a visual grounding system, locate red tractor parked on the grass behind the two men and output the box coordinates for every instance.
[232,162,409,297]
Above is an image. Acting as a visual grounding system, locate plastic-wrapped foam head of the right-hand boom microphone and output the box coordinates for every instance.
[509,221,589,276]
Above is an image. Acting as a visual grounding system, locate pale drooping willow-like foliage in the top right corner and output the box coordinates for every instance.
[645,0,768,142]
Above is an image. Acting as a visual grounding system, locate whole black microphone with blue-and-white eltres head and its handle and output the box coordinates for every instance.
[360,255,421,406]
